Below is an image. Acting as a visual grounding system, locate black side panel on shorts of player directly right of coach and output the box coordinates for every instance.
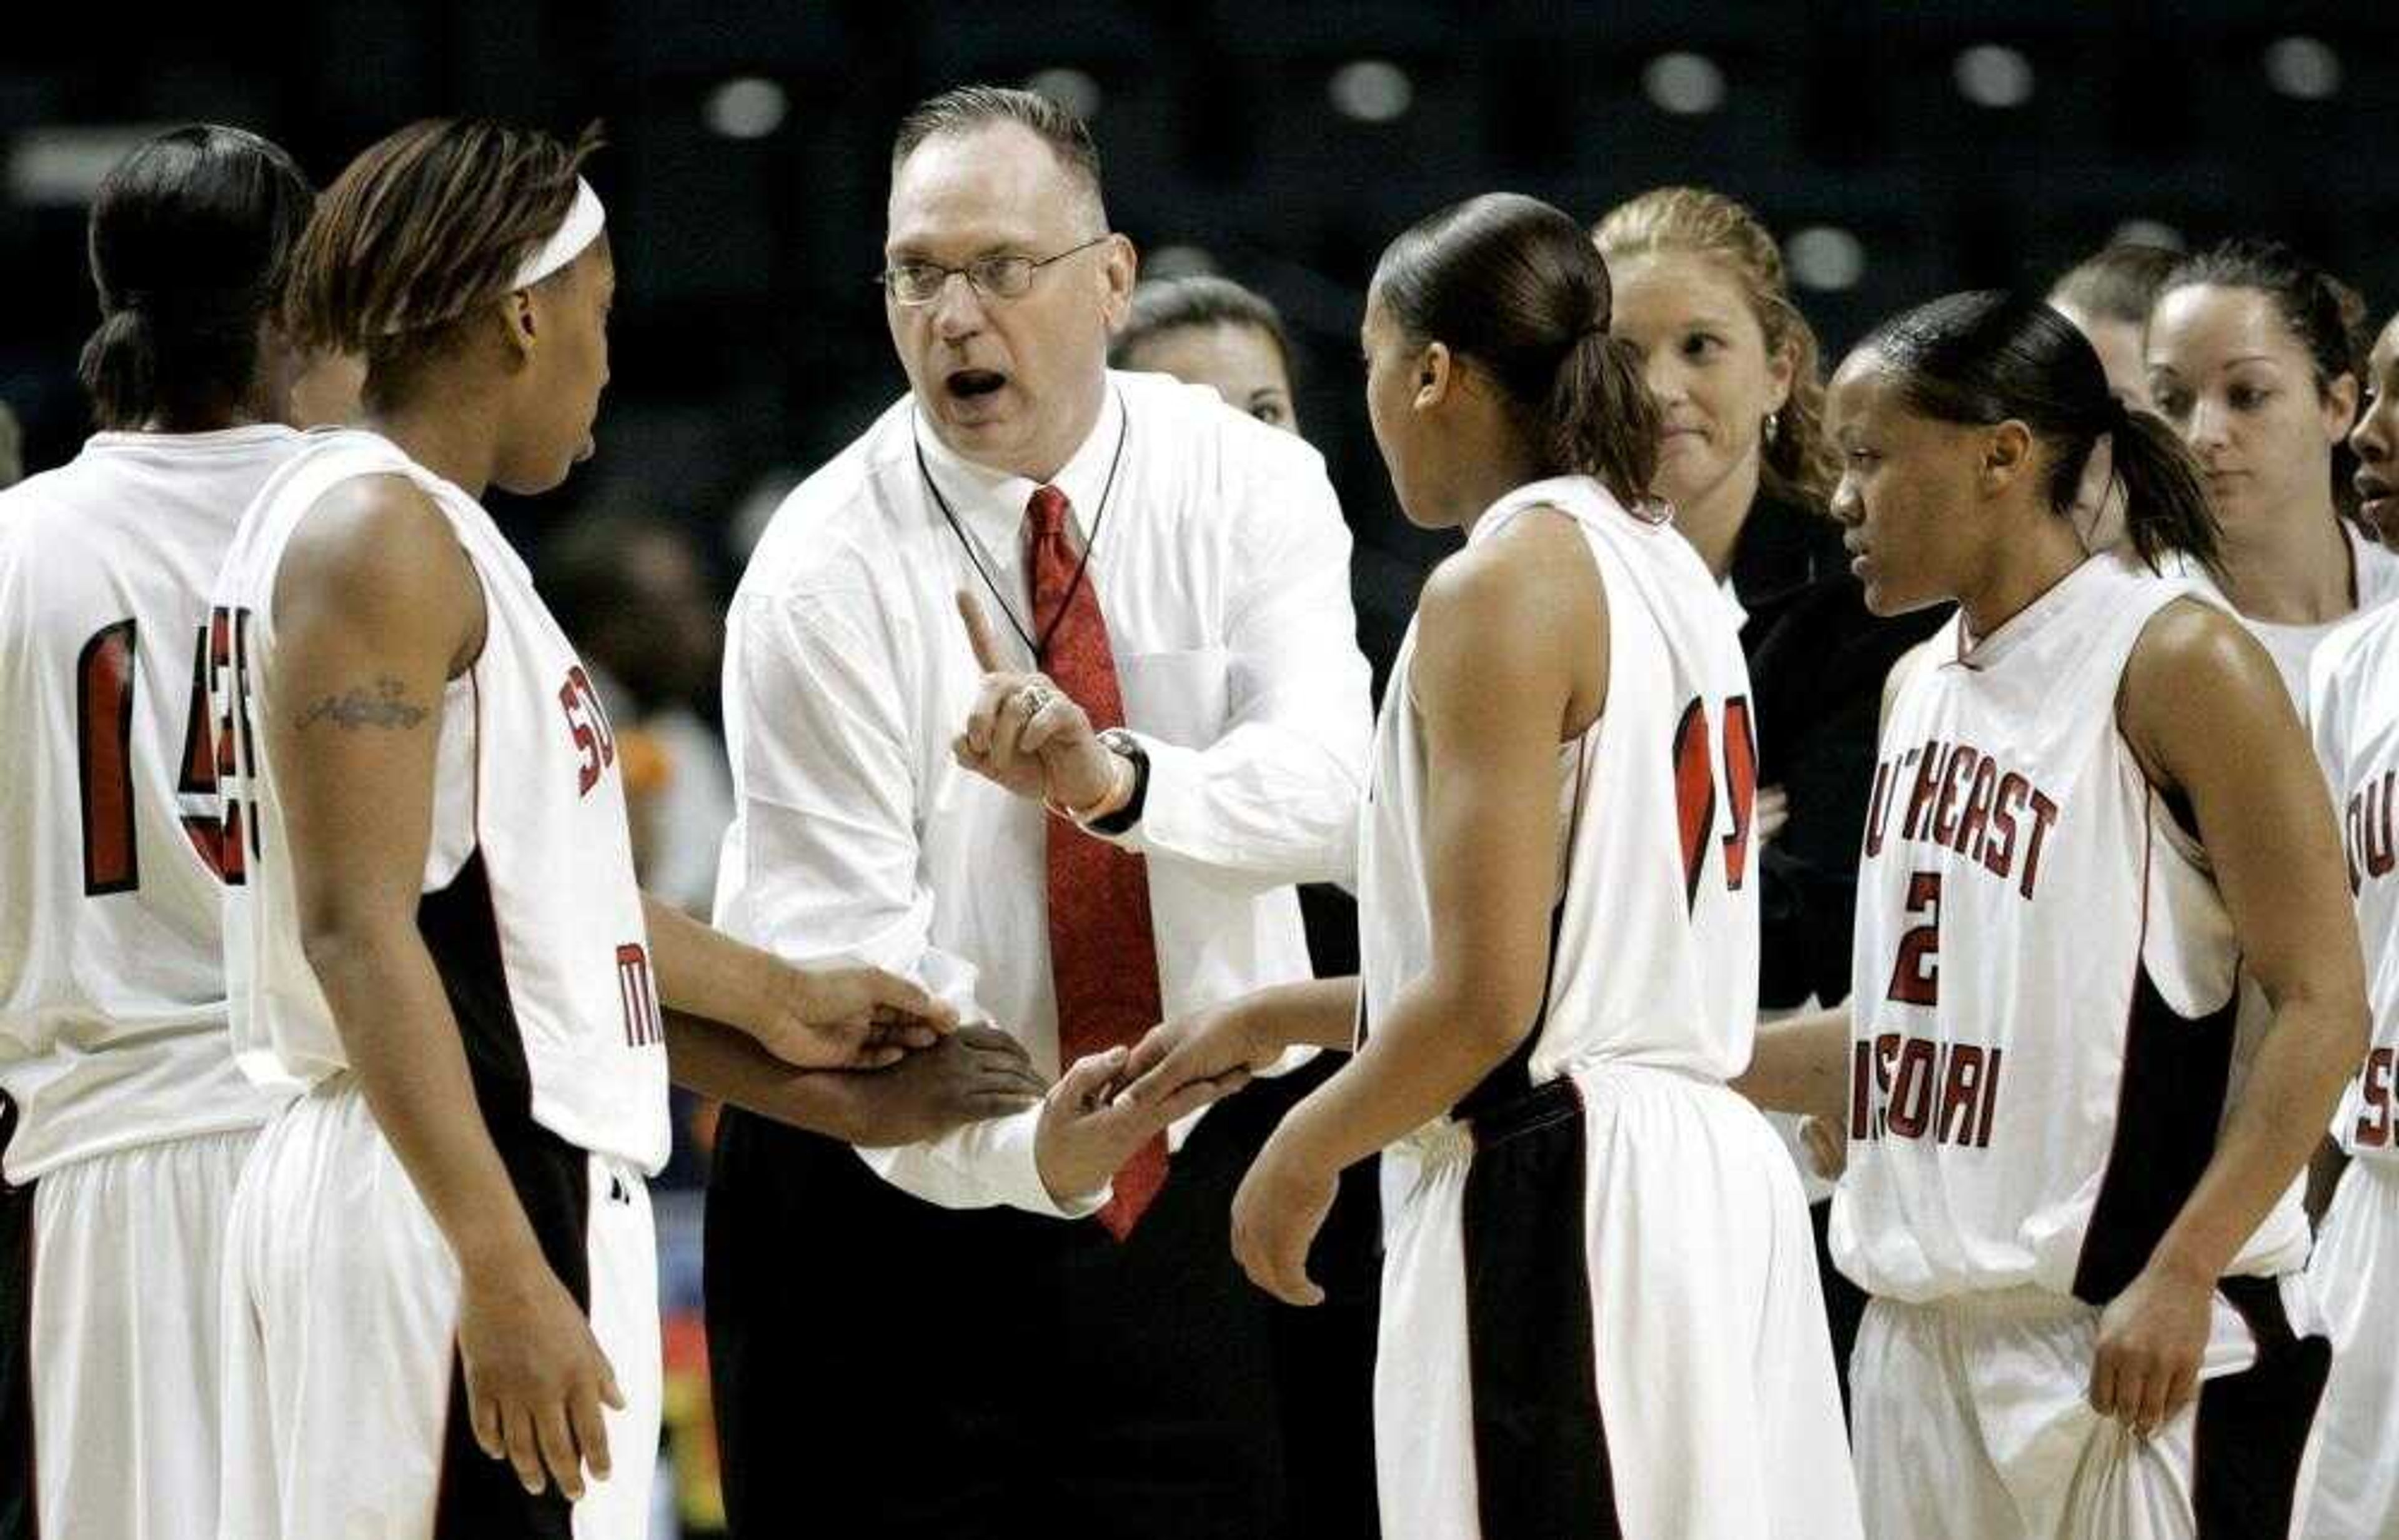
[1463,1080,1624,1540]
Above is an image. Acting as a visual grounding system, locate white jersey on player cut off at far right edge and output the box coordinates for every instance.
[2308,607,2399,1161]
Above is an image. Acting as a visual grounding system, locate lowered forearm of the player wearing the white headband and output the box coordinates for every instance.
[307,923,540,1271]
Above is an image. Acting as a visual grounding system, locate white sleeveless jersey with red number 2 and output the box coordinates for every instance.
[1833,557,2308,1305]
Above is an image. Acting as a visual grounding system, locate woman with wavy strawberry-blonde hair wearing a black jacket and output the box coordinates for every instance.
[1593,187,1941,1401]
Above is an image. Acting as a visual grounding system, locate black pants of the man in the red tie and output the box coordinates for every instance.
[708,1070,1379,1540]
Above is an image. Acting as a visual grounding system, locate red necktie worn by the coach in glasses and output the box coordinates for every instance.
[1025,487,1166,1240]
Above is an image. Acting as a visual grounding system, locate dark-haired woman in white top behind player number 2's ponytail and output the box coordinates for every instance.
[2147,240,2399,708]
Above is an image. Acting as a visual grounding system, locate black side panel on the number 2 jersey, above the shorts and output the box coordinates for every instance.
[2075,969,2241,1308]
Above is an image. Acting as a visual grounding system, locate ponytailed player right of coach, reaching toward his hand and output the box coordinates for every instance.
[1128,194,1857,1538]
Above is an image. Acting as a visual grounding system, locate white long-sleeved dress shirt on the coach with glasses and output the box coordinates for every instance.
[717,372,1372,1216]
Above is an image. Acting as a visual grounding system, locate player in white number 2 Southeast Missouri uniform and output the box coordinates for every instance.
[1744,292,2363,1540]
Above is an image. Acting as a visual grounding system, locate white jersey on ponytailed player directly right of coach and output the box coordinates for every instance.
[1358,477,1759,1115]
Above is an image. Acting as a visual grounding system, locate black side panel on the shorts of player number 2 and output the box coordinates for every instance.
[2190,1278,2332,1540]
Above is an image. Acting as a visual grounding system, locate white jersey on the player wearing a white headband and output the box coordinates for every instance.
[216,432,667,1171]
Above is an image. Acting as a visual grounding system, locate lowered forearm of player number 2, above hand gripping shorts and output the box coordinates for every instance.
[2150,995,2365,1283]
